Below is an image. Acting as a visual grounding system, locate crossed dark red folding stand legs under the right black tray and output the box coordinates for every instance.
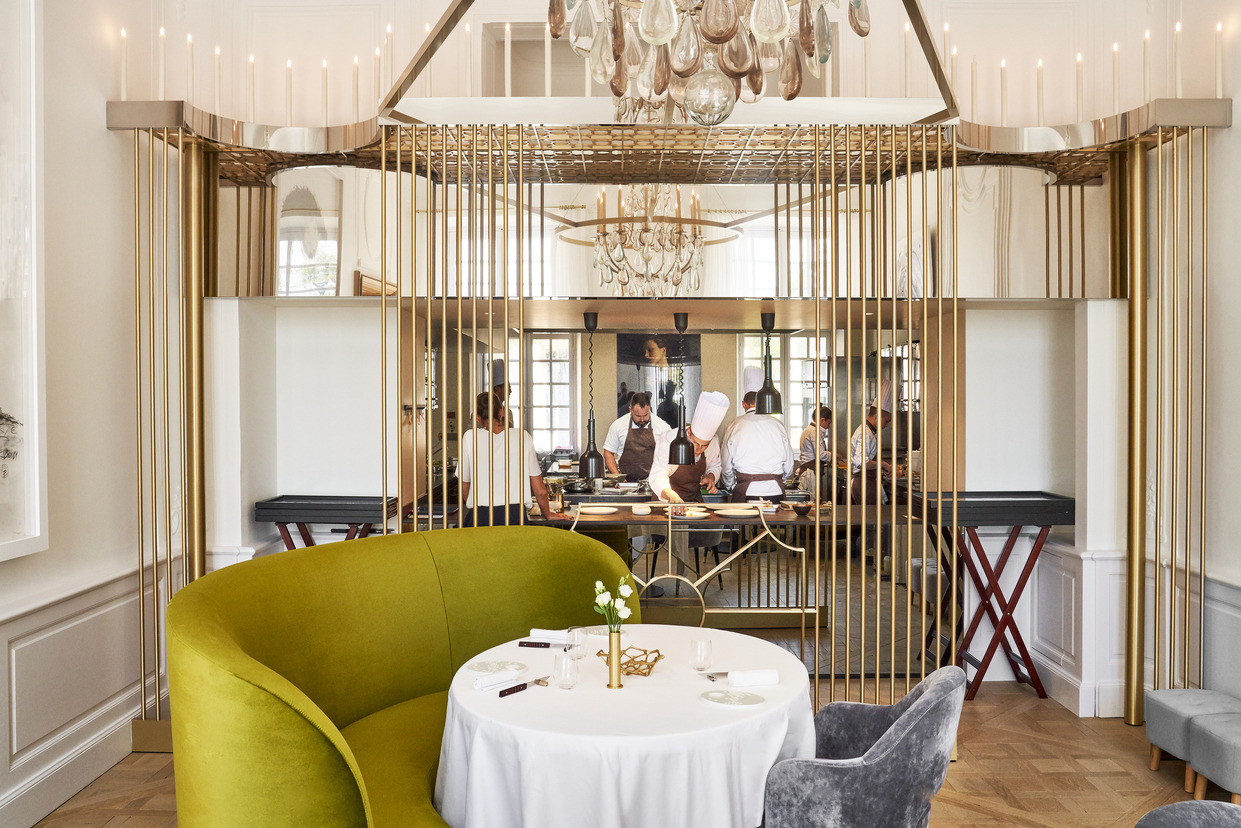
[958,526,1051,699]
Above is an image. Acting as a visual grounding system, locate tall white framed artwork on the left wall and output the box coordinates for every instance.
[0,0,47,560]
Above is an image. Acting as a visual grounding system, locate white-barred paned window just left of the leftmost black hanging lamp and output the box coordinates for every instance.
[525,333,576,453]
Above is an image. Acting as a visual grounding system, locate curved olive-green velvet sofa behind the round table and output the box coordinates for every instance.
[168,526,639,828]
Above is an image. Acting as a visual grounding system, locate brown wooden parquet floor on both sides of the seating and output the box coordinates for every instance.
[38,683,1226,828]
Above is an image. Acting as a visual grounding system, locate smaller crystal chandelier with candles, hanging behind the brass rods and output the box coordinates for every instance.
[594,184,706,297]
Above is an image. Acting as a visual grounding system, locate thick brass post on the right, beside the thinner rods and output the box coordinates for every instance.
[1124,143,1151,725]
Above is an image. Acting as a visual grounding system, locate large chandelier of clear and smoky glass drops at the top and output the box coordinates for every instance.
[547,0,870,127]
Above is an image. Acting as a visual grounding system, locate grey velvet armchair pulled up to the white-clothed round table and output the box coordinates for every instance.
[763,667,965,828]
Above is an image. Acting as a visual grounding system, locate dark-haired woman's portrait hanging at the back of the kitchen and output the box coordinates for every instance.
[617,334,702,428]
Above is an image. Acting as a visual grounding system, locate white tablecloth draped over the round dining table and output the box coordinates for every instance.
[436,624,814,828]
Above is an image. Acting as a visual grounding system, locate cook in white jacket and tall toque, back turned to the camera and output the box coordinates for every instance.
[720,367,794,503]
